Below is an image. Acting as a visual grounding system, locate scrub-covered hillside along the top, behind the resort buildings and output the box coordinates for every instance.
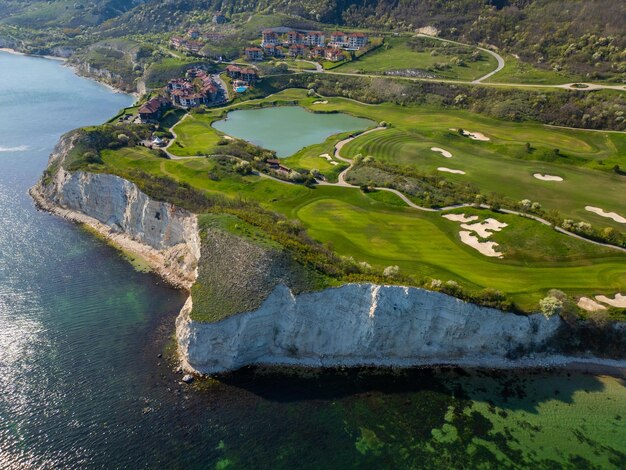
[0,0,626,81]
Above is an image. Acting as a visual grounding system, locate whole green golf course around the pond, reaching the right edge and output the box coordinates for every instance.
[98,90,626,311]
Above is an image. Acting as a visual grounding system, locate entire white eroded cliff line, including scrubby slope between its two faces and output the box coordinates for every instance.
[31,133,626,374]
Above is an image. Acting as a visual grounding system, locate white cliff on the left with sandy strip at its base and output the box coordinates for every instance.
[31,134,200,290]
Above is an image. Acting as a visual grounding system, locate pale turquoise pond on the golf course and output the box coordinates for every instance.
[213,106,375,157]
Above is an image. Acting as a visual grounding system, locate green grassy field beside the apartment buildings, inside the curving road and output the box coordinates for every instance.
[334,36,497,81]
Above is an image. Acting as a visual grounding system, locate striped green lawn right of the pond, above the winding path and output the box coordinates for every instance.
[342,129,626,231]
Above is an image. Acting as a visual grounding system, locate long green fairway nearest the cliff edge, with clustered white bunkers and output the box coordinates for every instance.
[98,143,626,310]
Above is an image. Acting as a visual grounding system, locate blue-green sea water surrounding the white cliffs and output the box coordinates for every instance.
[0,53,626,469]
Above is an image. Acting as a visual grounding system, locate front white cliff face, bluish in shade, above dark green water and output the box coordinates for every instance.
[177,284,562,374]
